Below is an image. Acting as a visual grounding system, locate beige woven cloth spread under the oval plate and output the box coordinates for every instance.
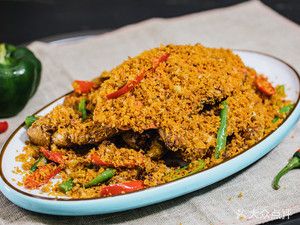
[0,1,300,225]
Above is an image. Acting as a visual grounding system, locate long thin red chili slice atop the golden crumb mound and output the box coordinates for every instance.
[106,53,170,99]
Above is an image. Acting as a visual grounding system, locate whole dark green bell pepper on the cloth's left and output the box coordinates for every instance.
[0,43,42,118]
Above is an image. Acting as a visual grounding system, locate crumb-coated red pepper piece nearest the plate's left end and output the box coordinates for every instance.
[24,163,61,189]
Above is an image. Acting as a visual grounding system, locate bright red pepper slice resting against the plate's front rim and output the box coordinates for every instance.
[100,180,145,196]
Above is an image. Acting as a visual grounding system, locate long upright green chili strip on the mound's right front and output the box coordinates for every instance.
[215,100,228,159]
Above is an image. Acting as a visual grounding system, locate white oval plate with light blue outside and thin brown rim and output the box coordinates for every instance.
[0,50,300,216]
